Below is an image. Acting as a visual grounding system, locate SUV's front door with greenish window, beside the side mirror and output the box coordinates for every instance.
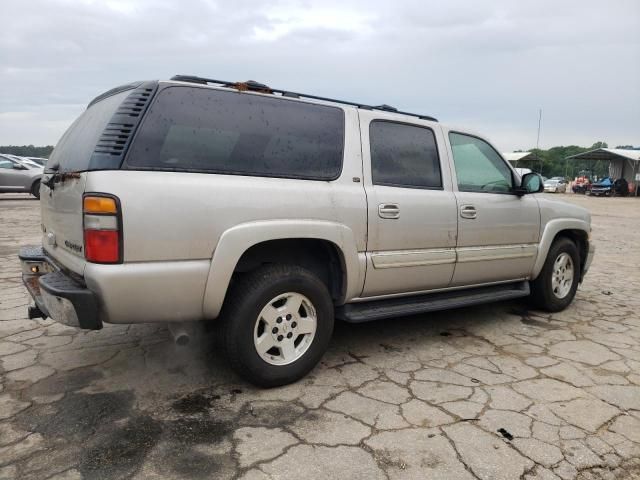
[448,131,540,286]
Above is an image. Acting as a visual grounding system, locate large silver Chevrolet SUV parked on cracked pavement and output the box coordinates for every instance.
[20,76,594,386]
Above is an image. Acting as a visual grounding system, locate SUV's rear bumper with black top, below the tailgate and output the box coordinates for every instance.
[18,247,102,330]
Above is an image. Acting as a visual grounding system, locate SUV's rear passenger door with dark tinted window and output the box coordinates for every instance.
[359,110,457,297]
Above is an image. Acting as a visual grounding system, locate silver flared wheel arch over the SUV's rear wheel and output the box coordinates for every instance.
[203,220,365,318]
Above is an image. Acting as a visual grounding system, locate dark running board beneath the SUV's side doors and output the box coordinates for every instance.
[336,281,530,323]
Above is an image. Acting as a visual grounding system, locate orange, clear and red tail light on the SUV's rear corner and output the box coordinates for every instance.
[82,194,122,263]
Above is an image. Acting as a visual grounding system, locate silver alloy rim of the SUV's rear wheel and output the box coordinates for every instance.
[253,292,318,366]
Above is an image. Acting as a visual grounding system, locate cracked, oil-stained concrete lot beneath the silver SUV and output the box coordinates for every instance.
[0,195,640,480]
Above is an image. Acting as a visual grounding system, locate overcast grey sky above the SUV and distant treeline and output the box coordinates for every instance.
[0,0,640,151]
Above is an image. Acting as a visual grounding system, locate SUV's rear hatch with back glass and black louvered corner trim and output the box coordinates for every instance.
[40,82,155,275]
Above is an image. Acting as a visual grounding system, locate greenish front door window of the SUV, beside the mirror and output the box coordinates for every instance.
[449,132,513,193]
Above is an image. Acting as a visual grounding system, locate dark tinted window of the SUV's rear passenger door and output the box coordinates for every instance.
[369,121,442,188]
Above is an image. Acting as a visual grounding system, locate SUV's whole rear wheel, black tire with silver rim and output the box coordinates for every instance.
[219,264,334,387]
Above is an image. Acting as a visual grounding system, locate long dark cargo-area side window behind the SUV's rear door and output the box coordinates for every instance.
[127,87,344,180]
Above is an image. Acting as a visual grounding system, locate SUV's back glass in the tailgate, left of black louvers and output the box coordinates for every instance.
[47,90,131,172]
